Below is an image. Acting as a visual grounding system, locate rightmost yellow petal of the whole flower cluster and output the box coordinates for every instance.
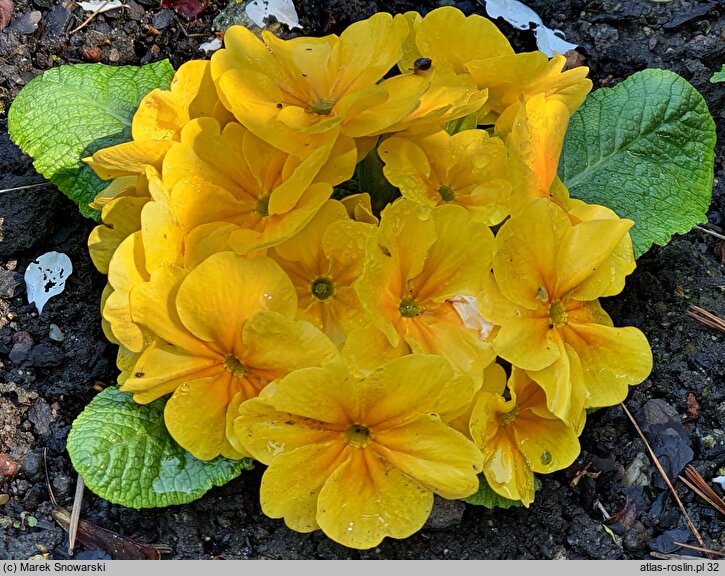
[565,322,652,408]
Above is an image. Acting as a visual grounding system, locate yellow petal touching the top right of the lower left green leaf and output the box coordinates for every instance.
[164,370,243,460]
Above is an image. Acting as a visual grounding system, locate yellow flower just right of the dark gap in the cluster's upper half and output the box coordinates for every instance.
[378,130,510,226]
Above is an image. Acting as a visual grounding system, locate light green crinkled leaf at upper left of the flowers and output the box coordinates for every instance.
[8,60,174,219]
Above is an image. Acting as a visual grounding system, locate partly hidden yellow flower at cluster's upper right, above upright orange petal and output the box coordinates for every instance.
[466,52,592,136]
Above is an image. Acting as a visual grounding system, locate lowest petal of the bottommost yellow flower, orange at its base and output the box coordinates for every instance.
[317,450,433,550]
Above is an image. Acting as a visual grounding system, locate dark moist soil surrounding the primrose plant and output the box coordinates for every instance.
[0,0,725,559]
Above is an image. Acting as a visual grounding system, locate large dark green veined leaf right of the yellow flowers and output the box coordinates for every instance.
[559,69,715,257]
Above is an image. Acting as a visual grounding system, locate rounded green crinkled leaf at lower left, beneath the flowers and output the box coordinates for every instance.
[67,387,253,508]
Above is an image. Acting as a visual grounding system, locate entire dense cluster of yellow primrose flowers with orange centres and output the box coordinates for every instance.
[86,7,652,549]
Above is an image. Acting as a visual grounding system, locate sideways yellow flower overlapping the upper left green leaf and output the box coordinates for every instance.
[84,60,233,186]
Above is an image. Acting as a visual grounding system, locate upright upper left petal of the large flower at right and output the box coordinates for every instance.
[493,199,571,310]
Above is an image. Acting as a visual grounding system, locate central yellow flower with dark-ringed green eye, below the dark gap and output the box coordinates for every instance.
[269,200,374,345]
